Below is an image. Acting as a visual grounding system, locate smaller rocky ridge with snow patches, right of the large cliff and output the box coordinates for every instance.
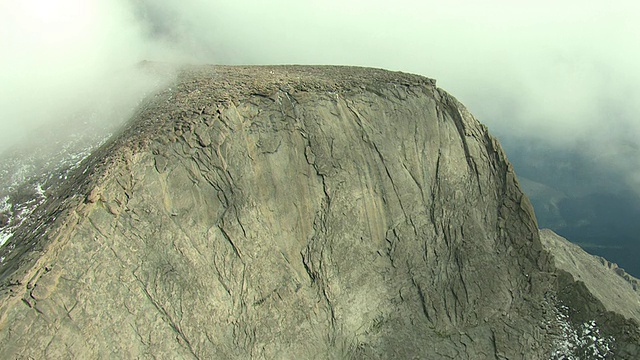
[540,229,640,359]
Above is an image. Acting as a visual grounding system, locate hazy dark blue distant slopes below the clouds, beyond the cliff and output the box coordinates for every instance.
[501,134,640,277]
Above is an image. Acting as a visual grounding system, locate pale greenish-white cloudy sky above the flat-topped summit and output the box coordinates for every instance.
[0,0,640,184]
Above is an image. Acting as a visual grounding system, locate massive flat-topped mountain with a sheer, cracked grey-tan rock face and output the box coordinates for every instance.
[0,66,640,359]
